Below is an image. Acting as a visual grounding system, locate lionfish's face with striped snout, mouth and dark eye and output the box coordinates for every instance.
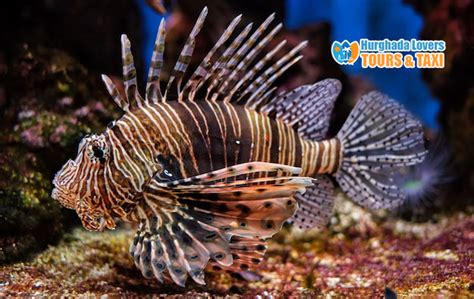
[51,135,115,231]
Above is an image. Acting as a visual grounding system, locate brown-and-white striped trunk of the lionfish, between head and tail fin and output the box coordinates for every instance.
[106,101,341,186]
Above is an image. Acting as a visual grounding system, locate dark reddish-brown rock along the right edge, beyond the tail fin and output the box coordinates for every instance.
[407,0,474,210]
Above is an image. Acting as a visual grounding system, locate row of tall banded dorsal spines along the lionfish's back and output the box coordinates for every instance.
[107,7,306,113]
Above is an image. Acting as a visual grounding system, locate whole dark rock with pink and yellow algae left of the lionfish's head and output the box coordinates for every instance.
[0,44,120,263]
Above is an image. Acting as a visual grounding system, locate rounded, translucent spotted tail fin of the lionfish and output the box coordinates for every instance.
[335,92,426,209]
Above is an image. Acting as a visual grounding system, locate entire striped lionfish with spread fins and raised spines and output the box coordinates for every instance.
[52,8,425,286]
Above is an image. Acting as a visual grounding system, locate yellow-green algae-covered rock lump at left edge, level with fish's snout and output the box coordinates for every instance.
[0,146,63,263]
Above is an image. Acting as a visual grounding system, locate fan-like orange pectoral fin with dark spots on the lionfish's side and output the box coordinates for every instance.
[130,162,313,286]
